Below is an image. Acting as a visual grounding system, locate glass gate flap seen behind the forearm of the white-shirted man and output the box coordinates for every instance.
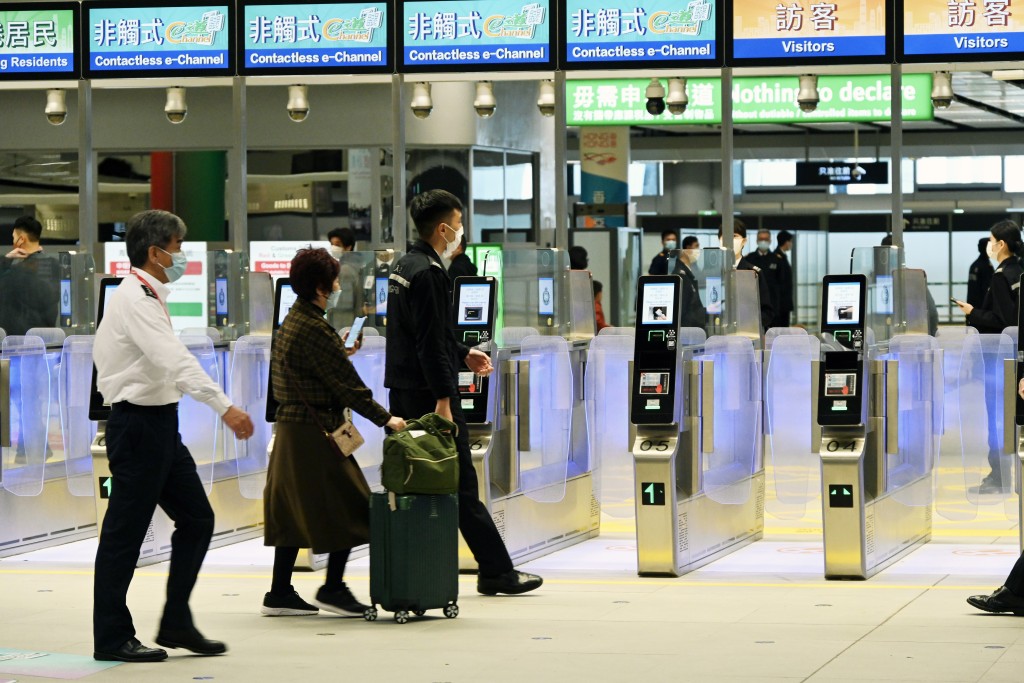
[178,335,220,495]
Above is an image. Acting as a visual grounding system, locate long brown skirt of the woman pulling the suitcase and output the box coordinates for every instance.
[263,422,370,553]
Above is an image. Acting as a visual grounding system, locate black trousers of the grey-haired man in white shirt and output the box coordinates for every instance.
[92,403,213,652]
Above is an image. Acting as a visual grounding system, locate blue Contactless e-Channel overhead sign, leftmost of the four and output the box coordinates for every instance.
[83,0,234,78]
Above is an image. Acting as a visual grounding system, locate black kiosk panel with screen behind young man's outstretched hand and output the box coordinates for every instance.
[454,276,498,424]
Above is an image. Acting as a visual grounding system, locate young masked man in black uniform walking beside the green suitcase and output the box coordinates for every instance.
[384,189,543,595]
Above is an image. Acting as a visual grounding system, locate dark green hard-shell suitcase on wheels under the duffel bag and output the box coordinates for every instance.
[364,494,459,624]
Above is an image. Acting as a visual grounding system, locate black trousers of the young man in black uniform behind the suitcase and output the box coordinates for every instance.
[388,389,512,577]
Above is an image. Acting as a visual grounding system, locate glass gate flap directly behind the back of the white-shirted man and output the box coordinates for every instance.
[57,335,96,498]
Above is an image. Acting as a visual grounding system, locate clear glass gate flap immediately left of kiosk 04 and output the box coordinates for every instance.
[764,328,821,519]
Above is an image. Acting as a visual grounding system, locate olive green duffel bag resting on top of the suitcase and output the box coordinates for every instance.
[381,413,459,496]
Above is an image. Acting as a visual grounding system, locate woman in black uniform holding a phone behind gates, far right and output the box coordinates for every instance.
[956,220,1024,494]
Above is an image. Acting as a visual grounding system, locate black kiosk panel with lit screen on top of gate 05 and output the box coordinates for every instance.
[630,275,683,425]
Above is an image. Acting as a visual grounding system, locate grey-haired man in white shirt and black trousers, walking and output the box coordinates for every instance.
[93,211,253,661]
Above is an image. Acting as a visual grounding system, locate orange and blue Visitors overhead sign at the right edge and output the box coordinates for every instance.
[896,0,1024,61]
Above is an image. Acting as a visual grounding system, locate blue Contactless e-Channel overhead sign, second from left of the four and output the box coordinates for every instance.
[238,0,394,76]
